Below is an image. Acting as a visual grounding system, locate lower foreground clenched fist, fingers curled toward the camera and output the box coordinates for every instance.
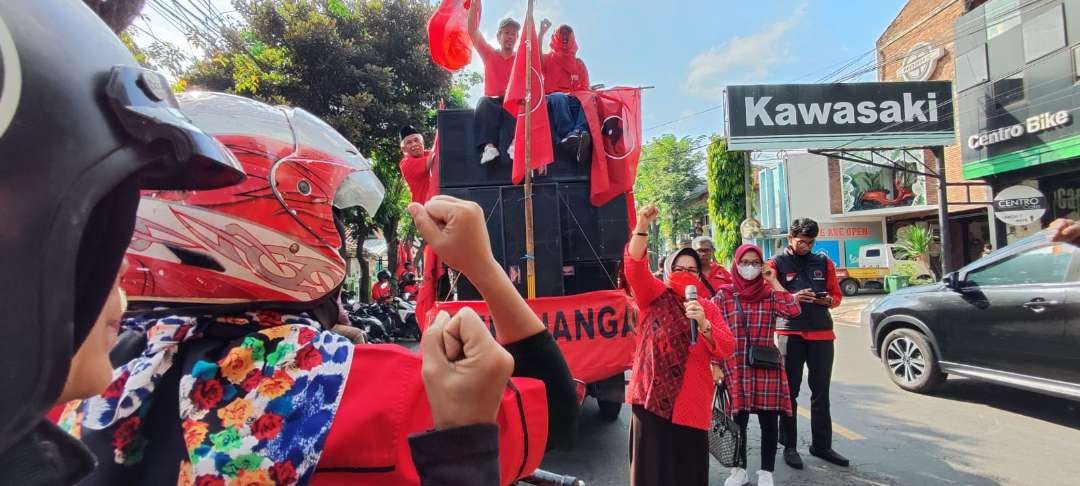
[420,308,514,430]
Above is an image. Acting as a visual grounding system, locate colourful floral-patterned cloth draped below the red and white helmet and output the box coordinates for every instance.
[59,312,354,486]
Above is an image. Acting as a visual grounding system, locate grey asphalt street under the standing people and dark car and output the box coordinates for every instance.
[533,296,1080,486]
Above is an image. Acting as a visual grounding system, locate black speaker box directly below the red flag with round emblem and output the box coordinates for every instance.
[558,183,630,261]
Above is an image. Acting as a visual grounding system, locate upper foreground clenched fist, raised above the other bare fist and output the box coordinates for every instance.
[408,195,498,280]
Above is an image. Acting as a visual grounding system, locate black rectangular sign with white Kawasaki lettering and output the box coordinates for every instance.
[727,81,956,150]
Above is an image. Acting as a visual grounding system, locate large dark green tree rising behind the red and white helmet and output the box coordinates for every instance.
[173,0,455,294]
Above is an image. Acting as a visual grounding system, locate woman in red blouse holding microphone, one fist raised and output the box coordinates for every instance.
[625,204,734,486]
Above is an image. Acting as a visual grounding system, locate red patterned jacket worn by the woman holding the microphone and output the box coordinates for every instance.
[623,251,735,430]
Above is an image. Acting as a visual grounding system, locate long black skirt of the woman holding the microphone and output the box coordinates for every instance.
[630,405,708,486]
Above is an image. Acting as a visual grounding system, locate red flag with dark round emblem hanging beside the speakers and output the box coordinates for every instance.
[573,87,642,207]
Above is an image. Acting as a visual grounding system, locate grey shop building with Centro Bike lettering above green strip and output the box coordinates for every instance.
[956,0,1080,244]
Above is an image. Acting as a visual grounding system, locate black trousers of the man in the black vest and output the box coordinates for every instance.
[779,336,836,449]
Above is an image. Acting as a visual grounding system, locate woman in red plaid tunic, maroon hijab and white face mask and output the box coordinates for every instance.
[713,244,799,486]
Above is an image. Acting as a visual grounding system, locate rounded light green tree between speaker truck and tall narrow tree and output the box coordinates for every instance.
[634,134,704,249]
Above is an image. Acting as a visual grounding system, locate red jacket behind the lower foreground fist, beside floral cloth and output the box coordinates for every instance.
[311,345,548,486]
